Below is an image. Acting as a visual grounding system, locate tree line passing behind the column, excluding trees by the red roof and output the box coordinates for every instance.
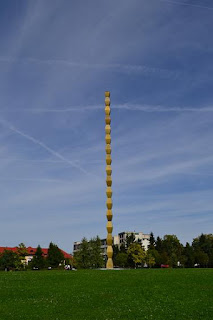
[74,232,213,269]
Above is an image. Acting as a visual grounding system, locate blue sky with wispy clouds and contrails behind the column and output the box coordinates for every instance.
[0,0,213,252]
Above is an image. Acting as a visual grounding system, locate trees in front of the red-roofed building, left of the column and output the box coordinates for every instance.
[0,242,68,270]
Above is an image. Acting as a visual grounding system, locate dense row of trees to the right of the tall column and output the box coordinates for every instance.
[114,232,213,268]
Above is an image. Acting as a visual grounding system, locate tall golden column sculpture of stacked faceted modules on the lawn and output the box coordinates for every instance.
[105,91,113,269]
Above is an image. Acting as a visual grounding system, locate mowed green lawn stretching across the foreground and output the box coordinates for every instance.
[0,269,213,320]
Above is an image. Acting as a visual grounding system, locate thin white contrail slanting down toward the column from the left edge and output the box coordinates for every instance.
[0,119,88,174]
